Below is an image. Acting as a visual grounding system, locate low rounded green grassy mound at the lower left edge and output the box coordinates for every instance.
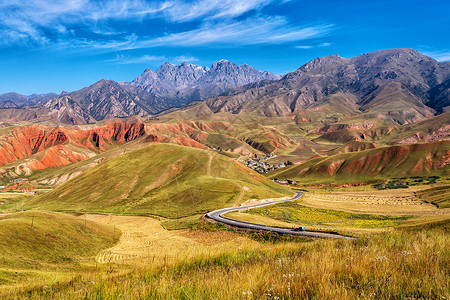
[0,211,119,284]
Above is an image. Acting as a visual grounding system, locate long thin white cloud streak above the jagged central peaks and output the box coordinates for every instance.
[132,17,333,48]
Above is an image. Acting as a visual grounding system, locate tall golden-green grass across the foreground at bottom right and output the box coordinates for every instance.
[10,219,450,299]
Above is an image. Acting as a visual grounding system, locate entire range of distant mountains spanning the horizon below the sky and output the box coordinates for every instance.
[0,49,450,126]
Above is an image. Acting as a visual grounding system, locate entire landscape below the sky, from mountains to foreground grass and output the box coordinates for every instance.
[0,49,450,299]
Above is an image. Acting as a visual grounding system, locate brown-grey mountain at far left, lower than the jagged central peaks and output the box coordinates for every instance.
[0,79,161,124]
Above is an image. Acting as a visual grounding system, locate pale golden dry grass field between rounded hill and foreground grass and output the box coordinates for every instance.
[84,215,274,266]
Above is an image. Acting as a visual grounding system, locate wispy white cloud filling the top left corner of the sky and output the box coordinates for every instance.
[0,0,173,44]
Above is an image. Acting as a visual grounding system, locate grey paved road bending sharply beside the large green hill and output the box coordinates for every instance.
[206,192,354,239]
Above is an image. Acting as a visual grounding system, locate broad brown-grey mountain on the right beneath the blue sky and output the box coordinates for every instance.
[200,49,450,124]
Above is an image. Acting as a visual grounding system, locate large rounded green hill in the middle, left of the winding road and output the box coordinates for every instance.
[32,144,292,217]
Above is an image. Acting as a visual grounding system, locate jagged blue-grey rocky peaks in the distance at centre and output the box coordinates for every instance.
[131,60,280,107]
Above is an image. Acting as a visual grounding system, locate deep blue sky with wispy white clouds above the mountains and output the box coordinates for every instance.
[0,0,450,95]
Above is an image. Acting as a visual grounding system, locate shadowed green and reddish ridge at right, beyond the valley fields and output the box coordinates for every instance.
[270,141,450,183]
